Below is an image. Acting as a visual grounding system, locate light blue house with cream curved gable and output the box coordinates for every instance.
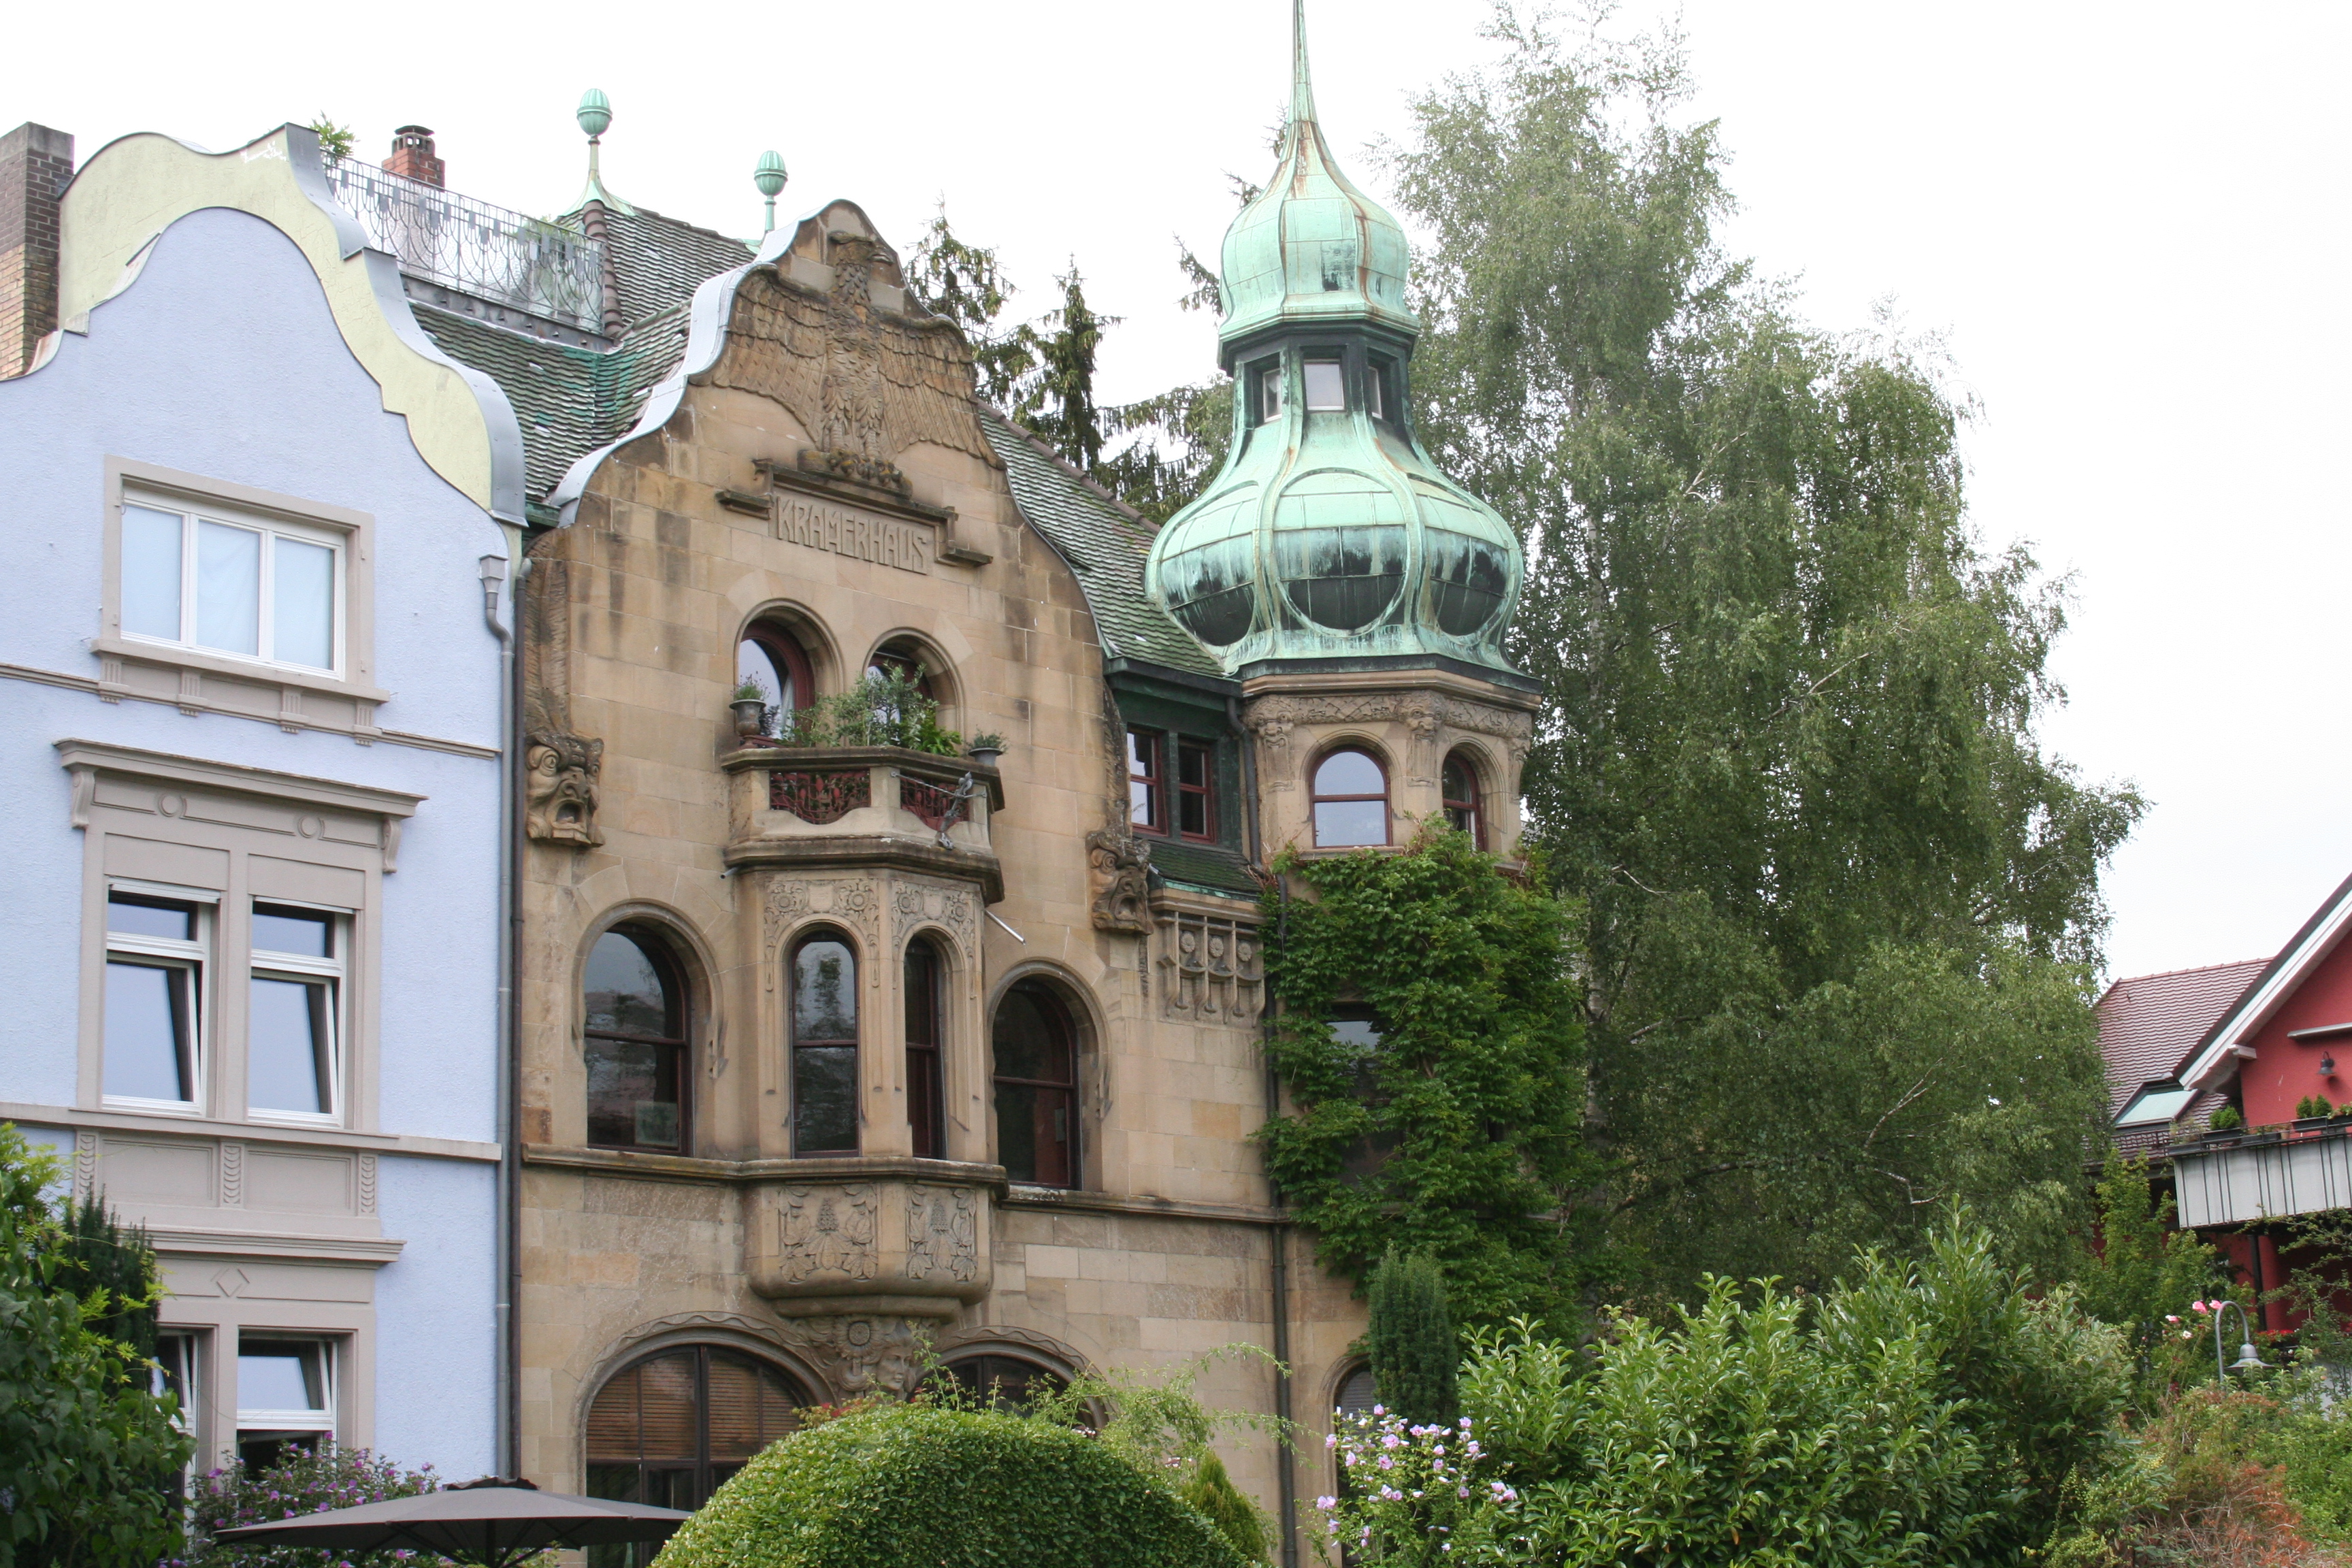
[0,127,522,1476]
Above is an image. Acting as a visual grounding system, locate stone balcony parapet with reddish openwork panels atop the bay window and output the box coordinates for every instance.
[720,745,1004,902]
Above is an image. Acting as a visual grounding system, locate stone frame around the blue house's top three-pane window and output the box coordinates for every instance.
[89,456,391,715]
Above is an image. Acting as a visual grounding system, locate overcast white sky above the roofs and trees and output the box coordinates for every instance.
[22,0,2352,976]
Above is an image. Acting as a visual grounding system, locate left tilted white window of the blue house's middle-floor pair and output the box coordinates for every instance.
[101,881,218,1112]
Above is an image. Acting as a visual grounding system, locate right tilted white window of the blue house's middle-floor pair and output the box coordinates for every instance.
[244,900,350,1124]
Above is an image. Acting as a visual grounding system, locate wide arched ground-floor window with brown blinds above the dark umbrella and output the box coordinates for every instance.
[588,1345,809,1523]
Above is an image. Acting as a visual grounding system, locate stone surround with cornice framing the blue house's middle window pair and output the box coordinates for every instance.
[56,740,426,1133]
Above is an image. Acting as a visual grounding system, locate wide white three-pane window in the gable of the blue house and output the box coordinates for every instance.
[120,491,348,674]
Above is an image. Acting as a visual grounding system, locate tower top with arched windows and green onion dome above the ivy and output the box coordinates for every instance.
[1148,0,1536,853]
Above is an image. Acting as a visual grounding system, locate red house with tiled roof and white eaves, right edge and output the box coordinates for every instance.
[2098,879,2352,1328]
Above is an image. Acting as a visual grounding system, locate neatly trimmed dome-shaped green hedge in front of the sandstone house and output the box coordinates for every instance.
[654,1406,1249,1568]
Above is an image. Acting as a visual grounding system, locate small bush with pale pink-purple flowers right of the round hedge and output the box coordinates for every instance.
[1315,1406,1520,1566]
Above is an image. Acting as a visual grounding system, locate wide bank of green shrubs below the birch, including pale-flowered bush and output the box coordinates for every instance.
[1317,1222,2131,1568]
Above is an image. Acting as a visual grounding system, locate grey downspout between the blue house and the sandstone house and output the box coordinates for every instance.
[482,555,529,1479]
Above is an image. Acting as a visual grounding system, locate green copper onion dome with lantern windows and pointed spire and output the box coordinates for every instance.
[1148,0,1526,679]
